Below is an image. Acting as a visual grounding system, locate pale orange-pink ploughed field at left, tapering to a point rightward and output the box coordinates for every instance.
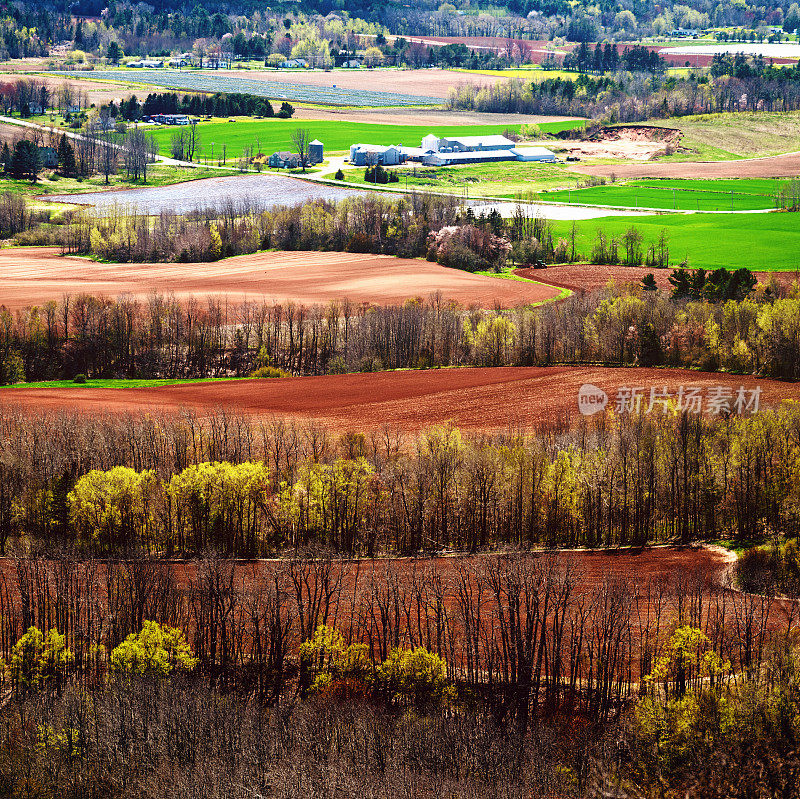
[0,247,560,310]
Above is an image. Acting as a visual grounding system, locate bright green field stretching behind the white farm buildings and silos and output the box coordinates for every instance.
[148,117,584,159]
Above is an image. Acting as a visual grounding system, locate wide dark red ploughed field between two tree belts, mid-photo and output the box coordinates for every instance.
[0,367,800,432]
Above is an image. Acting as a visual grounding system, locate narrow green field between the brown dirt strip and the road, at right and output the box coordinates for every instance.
[541,178,781,211]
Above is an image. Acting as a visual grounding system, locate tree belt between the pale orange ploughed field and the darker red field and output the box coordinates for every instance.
[0,276,800,383]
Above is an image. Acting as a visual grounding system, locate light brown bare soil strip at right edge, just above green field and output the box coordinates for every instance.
[570,153,800,180]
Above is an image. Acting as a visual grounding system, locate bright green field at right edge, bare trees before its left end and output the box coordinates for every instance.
[553,213,800,272]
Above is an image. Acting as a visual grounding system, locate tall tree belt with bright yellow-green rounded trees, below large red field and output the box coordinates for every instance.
[0,406,800,557]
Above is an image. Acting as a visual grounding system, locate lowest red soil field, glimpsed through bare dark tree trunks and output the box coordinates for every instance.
[0,546,797,680]
